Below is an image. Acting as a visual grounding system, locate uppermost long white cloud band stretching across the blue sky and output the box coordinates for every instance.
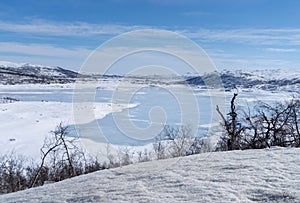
[0,18,300,45]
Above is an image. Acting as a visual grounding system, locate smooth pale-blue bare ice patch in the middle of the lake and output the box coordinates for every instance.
[72,86,217,145]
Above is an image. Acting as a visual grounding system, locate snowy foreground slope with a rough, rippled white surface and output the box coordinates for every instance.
[0,148,300,202]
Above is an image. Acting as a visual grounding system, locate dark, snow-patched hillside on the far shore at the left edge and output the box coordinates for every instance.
[0,61,78,84]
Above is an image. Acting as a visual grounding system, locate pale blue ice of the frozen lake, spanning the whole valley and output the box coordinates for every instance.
[0,82,290,145]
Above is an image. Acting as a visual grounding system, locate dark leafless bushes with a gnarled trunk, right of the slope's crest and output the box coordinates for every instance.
[217,94,300,150]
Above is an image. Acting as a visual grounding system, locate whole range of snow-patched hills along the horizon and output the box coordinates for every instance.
[0,61,300,91]
